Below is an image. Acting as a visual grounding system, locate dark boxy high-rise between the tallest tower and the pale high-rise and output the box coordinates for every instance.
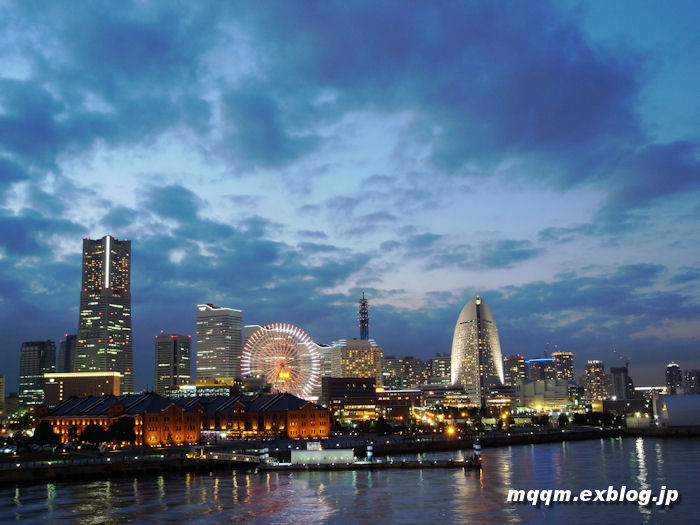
[153,334,192,395]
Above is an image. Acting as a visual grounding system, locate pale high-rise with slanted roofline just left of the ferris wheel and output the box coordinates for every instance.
[197,304,243,378]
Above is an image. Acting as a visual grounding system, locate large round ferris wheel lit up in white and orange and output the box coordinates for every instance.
[241,323,321,398]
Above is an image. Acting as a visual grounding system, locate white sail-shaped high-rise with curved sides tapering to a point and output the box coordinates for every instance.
[452,295,505,408]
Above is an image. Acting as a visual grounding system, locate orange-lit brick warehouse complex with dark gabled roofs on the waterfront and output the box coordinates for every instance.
[37,392,331,446]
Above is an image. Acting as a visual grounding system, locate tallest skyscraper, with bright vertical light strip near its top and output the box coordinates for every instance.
[75,235,134,394]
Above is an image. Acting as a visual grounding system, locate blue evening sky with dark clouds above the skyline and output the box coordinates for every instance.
[0,0,700,390]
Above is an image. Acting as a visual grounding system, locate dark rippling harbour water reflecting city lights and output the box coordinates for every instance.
[0,438,700,525]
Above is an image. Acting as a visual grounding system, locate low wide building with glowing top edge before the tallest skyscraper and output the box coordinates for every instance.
[44,372,121,406]
